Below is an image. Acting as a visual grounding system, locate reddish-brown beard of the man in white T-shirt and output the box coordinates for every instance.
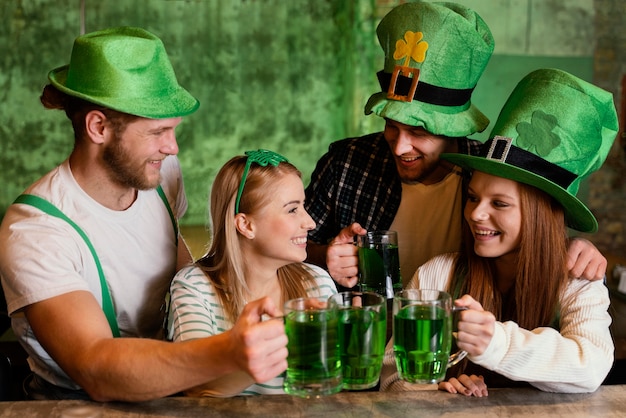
[102,133,161,190]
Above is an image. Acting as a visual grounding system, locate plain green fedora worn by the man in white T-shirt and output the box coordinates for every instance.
[48,27,199,119]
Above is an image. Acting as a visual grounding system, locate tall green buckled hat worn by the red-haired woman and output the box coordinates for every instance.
[441,69,619,232]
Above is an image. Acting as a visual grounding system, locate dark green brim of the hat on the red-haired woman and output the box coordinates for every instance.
[441,154,598,233]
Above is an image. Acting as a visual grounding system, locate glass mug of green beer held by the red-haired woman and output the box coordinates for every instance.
[393,289,467,383]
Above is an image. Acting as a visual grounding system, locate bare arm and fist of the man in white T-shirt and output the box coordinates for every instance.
[25,291,287,401]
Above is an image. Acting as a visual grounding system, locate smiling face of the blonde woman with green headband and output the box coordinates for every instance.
[248,173,315,268]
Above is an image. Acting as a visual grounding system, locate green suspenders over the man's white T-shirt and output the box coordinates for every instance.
[13,185,178,337]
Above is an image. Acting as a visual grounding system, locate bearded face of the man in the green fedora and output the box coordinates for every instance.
[102,118,182,190]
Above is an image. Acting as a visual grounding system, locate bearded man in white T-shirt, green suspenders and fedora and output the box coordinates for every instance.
[0,27,287,401]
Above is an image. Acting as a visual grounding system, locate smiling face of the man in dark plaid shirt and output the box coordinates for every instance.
[384,119,454,184]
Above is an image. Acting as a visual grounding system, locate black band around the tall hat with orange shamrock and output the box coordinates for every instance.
[376,68,474,106]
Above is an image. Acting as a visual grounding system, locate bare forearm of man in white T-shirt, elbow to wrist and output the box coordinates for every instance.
[66,333,238,401]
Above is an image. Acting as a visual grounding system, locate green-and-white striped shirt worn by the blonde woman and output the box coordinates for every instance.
[168,264,337,395]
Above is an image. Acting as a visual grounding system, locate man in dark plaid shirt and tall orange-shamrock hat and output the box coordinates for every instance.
[305,2,607,287]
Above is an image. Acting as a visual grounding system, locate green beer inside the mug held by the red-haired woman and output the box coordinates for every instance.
[393,305,452,383]
